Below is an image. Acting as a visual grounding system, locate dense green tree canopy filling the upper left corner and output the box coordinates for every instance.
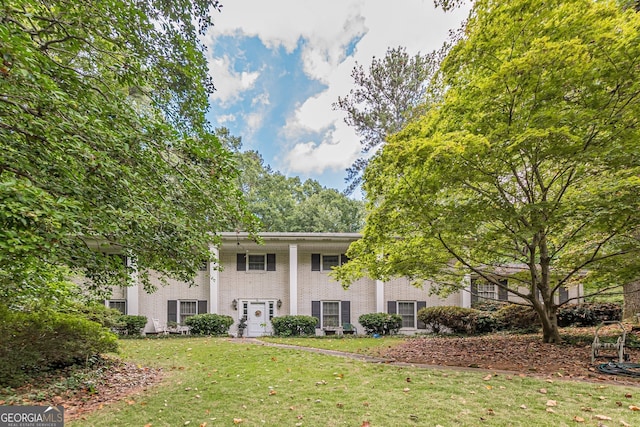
[0,0,253,299]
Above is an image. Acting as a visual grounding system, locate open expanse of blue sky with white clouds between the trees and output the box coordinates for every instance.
[204,0,468,195]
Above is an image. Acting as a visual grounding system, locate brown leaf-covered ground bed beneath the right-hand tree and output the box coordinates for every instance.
[380,331,640,386]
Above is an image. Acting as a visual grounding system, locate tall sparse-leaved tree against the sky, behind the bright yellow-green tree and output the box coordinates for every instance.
[333,47,442,194]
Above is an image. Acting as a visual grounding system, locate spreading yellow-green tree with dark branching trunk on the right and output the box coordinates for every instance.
[337,0,640,342]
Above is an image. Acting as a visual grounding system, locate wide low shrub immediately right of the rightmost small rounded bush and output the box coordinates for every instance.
[418,306,497,334]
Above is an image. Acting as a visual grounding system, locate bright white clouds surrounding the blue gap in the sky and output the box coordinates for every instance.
[208,0,469,186]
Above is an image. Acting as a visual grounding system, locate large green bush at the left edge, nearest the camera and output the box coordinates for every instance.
[0,305,118,387]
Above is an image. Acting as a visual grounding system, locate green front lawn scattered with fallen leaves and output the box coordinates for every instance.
[67,338,640,427]
